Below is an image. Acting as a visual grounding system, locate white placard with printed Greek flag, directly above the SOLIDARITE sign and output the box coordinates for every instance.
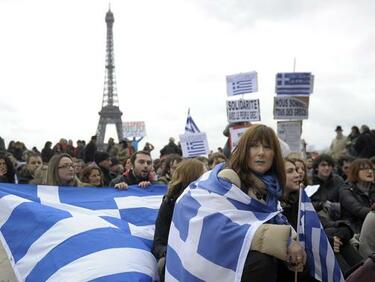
[227,71,258,96]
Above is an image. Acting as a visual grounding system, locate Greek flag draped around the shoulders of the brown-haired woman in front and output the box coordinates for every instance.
[165,164,279,282]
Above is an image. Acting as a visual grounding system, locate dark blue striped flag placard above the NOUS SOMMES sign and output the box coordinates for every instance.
[275,72,314,96]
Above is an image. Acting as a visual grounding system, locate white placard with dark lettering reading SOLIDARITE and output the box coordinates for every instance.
[227,99,260,123]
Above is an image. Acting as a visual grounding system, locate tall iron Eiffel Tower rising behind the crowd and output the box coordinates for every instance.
[96,8,123,150]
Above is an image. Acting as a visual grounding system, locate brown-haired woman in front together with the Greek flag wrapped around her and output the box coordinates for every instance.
[165,124,306,282]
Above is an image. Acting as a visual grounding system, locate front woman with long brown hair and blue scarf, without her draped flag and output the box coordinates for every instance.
[223,124,306,281]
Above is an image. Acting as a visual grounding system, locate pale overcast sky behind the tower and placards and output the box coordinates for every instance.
[0,0,375,158]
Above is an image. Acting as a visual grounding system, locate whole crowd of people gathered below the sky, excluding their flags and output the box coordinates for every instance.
[0,124,375,281]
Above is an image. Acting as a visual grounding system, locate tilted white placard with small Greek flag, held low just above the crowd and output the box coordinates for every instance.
[180,132,209,158]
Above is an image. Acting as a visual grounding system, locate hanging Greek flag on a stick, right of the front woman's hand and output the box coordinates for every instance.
[299,189,345,282]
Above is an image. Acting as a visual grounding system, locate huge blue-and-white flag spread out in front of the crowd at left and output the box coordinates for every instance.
[0,184,166,281]
